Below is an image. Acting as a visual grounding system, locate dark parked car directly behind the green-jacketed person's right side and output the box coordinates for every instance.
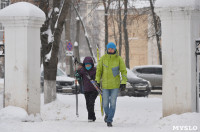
[121,68,151,96]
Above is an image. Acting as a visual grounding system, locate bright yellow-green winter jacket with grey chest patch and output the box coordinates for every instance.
[95,54,127,89]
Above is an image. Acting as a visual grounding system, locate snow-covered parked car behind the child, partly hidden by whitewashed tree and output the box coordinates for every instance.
[41,68,76,93]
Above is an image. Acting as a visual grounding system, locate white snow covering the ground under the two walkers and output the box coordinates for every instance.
[0,94,200,132]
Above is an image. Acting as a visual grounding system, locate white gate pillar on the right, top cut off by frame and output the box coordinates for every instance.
[156,0,200,116]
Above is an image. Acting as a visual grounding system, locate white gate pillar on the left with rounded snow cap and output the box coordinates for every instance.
[0,2,45,114]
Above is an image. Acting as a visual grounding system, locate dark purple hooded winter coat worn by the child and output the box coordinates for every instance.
[79,57,96,92]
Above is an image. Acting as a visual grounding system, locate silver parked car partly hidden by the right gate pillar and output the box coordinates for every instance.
[132,65,162,89]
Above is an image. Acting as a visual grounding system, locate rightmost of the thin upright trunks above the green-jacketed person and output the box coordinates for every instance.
[123,0,130,68]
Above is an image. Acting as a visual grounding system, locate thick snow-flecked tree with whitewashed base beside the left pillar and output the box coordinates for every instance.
[39,0,71,104]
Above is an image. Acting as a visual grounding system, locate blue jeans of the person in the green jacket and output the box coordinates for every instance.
[103,88,119,122]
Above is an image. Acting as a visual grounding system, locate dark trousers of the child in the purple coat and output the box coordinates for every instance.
[84,91,98,121]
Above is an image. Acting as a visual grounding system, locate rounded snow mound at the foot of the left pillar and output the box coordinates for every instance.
[0,106,28,122]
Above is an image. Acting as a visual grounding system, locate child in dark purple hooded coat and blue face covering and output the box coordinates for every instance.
[78,57,98,122]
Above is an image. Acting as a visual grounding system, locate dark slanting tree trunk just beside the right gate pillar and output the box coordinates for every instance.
[149,0,162,65]
